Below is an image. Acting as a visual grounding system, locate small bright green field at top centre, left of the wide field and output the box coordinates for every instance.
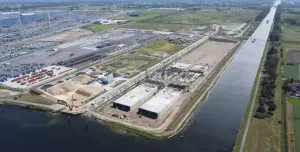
[118,10,170,21]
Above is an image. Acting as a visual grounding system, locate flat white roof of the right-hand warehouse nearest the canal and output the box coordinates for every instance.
[140,87,181,114]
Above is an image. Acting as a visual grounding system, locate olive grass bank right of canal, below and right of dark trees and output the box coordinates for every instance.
[244,47,282,152]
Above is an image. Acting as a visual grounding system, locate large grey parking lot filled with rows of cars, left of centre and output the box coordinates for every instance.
[0,29,165,74]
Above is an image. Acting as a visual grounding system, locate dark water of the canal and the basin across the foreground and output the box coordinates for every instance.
[0,3,275,152]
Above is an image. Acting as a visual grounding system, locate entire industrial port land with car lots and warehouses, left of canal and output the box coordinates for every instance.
[0,2,268,137]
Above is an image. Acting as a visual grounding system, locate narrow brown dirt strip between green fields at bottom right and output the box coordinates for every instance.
[287,102,296,152]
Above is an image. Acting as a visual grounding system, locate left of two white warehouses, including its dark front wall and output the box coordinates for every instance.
[113,83,158,111]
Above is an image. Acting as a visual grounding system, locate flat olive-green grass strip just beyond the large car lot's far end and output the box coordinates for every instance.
[122,23,194,31]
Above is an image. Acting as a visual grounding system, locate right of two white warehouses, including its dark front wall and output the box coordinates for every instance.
[138,87,181,119]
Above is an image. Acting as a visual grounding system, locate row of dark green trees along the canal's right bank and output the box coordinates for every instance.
[254,5,282,119]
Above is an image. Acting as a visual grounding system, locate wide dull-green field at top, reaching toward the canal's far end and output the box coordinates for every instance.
[147,9,260,24]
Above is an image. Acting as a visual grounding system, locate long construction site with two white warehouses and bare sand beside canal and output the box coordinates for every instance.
[91,40,240,135]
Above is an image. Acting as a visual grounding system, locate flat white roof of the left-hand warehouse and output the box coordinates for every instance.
[114,83,158,107]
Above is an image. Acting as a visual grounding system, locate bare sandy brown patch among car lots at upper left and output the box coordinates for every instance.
[37,28,93,42]
